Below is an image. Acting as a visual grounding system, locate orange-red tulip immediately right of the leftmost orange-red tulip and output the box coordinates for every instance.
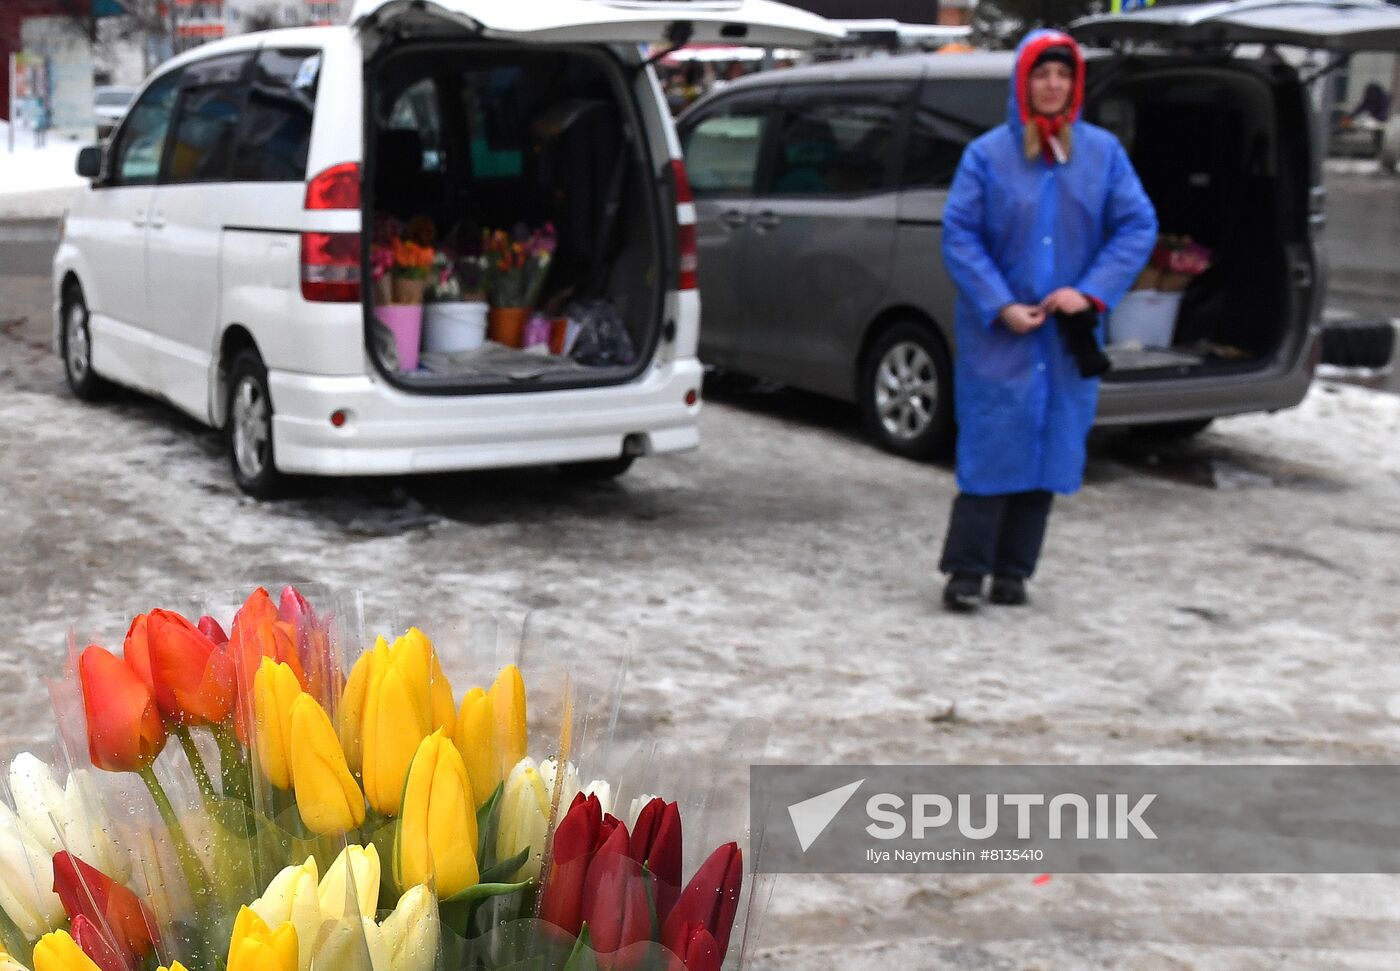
[146,610,234,725]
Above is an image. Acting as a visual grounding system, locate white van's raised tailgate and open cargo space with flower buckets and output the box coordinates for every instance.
[351,0,841,393]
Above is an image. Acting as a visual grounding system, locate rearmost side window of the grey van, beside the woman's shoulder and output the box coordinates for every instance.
[900,78,1007,189]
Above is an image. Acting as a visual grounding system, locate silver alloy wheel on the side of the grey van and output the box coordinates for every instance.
[860,320,953,459]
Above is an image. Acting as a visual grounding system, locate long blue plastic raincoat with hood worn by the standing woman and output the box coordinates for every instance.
[944,31,1156,495]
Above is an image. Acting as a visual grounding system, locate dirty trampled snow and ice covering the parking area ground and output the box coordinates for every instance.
[0,277,1400,971]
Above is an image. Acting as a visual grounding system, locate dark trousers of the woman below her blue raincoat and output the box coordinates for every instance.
[938,490,1054,579]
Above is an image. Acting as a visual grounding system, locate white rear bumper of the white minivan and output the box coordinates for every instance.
[267,357,703,476]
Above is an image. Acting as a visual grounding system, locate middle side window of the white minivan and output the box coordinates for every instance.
[161,55,251,183]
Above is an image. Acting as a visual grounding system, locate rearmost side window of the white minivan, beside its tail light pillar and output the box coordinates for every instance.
[232,49,321,182]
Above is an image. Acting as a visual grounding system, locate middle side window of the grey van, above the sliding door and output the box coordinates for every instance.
[771,101,899,196]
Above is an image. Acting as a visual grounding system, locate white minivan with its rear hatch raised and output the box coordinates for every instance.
[53,0,840,497]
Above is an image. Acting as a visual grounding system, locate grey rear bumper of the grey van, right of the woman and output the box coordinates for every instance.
[1093,332,1322,425]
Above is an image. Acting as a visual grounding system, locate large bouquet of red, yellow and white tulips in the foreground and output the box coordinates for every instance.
[0,588,753,971]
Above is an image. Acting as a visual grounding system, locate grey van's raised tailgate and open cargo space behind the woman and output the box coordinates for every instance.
[1071,0,1400,381]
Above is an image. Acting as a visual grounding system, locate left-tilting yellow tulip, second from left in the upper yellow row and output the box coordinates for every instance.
[290,694,364,835]
